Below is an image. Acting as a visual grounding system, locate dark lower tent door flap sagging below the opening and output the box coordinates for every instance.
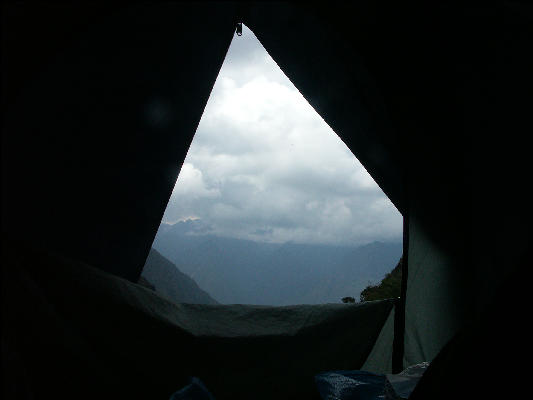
[2,241,393,399]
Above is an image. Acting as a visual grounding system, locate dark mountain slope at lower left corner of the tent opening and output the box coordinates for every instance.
[141,249,217,304]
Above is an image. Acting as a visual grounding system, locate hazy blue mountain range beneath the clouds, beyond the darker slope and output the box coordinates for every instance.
[147,220,402,305]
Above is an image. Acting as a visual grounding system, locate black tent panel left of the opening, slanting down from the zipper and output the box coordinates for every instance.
[2,2,236,280]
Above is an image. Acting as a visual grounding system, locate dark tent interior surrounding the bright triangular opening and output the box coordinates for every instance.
[1,1,533,399]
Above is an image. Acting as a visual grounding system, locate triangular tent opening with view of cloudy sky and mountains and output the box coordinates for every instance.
[143,26,402,305]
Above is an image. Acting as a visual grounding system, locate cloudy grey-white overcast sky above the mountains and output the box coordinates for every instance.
[163,26,402,245]
